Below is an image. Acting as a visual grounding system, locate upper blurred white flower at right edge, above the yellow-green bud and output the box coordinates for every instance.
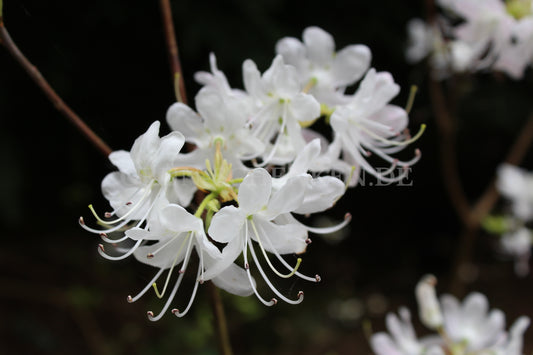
[497,164,533,221]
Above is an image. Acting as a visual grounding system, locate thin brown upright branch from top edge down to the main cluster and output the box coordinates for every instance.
[159,0,187,104]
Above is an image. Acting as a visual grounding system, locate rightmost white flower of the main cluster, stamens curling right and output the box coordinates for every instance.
[331,69,422,186]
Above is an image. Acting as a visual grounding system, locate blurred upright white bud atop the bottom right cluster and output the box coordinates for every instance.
[415,275,443,330]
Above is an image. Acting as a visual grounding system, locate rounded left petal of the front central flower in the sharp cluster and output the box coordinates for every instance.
[209,206,246,243]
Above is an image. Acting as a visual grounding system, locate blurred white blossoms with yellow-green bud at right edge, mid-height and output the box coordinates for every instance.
[483,164,533,276]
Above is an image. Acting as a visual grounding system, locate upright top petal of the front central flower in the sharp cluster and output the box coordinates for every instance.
[238,169,272,215]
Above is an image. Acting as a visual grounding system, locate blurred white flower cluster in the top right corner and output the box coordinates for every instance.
[406,0,533,79]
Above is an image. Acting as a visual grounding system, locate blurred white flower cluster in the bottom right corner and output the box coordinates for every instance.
[370,275,530,355]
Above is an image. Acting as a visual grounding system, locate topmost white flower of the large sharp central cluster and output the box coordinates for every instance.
[276,27,371,106]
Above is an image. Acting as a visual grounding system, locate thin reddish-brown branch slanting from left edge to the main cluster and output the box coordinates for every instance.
[0,20,112,156]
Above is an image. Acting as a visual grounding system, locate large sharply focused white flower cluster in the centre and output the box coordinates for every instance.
[80,27,423,320]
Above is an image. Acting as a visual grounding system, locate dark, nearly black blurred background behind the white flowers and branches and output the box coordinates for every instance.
[0,0,533,355]
